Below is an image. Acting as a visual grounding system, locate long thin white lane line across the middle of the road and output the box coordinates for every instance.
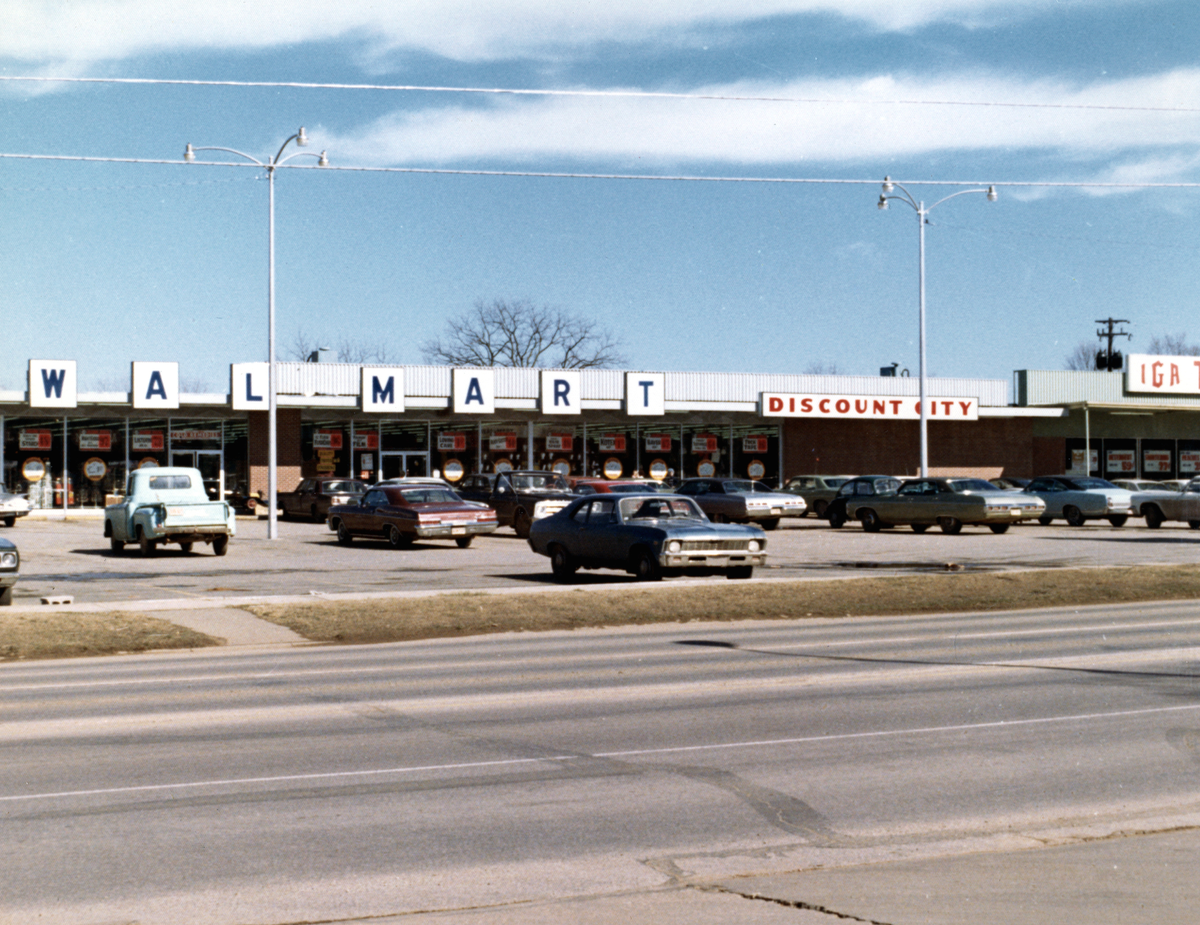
[0,703,1200,803]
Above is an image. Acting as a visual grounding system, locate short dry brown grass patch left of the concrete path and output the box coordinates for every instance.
[0,612,221,661]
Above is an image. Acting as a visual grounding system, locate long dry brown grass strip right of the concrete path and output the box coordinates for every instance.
[238,565,1200,643]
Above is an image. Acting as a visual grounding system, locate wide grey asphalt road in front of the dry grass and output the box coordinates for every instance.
[0,603,1200,925]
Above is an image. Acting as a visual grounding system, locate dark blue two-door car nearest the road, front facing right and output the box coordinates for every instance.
[529,493,767,581]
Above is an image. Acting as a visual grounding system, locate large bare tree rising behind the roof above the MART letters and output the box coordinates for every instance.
[421,299,625,370]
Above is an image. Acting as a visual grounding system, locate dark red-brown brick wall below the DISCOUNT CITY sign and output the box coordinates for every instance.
[784,418,1037,479]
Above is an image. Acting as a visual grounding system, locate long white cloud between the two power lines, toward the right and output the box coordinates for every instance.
[319,70,1200,173]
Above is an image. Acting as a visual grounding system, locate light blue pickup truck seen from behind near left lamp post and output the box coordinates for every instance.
[104,467,238,555]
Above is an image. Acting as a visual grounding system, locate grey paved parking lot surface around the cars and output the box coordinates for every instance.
[2,518,1200,606]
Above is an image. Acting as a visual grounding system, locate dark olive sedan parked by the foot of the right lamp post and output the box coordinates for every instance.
[846,479,1045,535]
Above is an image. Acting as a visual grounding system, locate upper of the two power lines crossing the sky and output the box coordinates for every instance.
[0,74,1200,113]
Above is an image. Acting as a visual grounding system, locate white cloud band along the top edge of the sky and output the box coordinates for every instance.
[0,0,1129,66]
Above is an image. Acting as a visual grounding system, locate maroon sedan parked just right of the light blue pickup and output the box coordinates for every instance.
[329,485,500,549]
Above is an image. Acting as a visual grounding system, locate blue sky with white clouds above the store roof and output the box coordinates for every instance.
[0,0,1200,391]
